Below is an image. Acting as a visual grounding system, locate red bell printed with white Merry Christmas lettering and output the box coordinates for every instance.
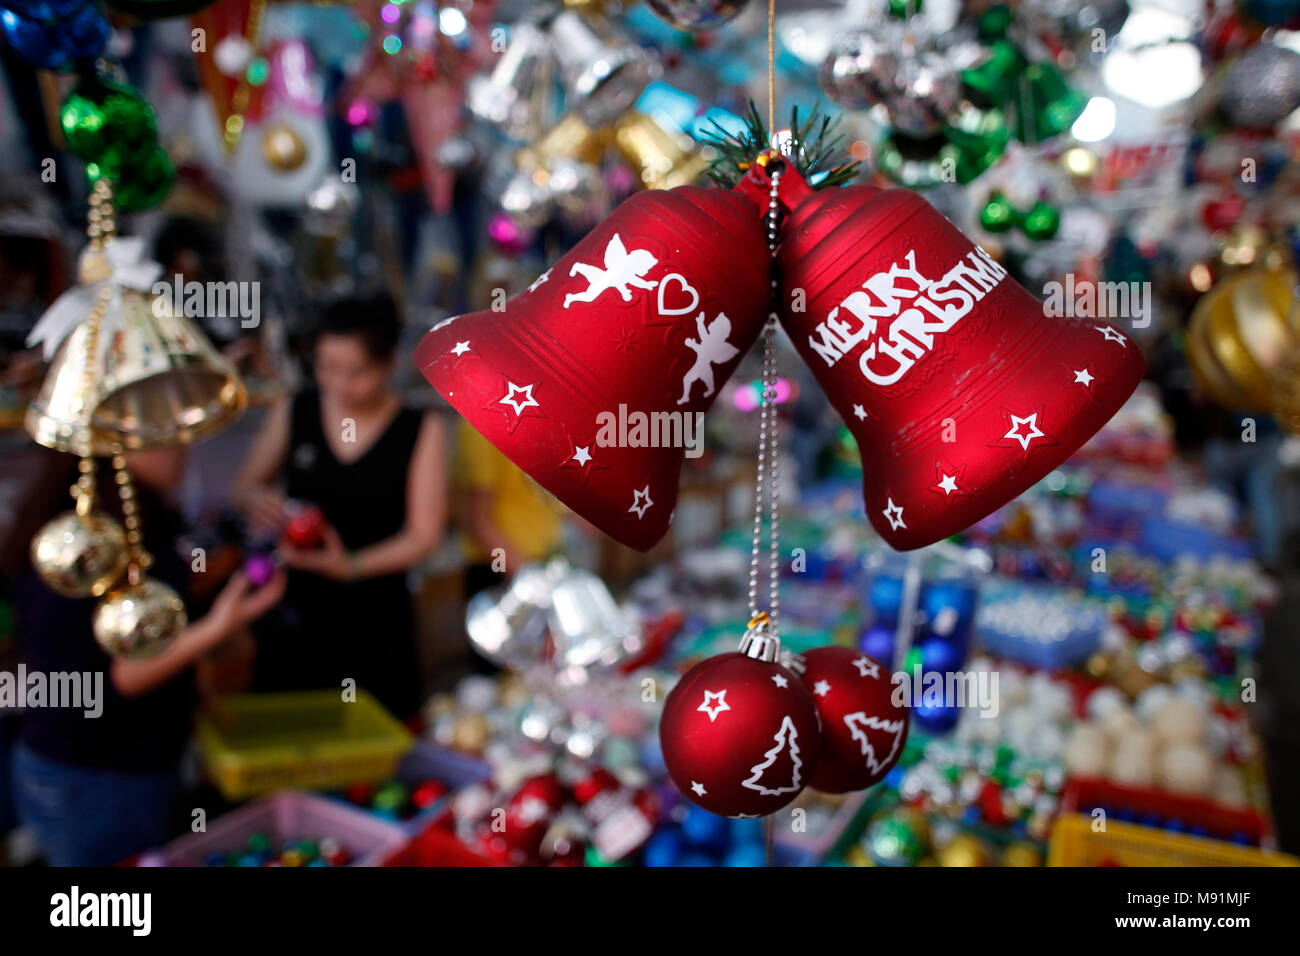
[779,170,1145,550]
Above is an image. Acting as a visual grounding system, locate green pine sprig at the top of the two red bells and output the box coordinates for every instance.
[703,100,859,189]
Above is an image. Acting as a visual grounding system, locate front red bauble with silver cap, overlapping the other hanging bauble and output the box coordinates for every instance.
[659,618,820,817]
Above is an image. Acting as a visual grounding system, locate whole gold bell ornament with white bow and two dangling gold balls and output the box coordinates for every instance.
[27,179,205,657]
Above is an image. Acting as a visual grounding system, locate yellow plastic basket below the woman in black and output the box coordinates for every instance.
[198,691,411,800]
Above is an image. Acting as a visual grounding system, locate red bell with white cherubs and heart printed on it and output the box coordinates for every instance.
[416,186,770,550]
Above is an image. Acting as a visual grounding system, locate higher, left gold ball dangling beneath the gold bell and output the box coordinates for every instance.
[31,511,127,597]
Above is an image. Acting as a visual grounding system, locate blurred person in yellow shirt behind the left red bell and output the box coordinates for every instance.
[456,419,563,600]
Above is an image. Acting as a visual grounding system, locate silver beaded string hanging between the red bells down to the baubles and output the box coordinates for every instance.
[749,169,781,639]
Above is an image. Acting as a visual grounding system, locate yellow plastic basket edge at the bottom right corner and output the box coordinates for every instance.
[1048,813,1300,866]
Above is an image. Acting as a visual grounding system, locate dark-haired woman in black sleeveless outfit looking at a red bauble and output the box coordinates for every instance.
[234,291,447,719]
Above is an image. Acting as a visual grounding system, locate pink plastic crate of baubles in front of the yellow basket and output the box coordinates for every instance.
[149,791,407,866]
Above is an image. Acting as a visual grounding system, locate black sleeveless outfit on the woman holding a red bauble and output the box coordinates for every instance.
[254,390,421,719]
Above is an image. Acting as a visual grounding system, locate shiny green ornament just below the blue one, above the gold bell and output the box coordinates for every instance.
[59,77,159,181]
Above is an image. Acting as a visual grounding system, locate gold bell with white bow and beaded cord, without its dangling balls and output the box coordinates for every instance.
[26,178,248,455]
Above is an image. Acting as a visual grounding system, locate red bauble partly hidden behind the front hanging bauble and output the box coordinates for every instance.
[800,648,907,793]
